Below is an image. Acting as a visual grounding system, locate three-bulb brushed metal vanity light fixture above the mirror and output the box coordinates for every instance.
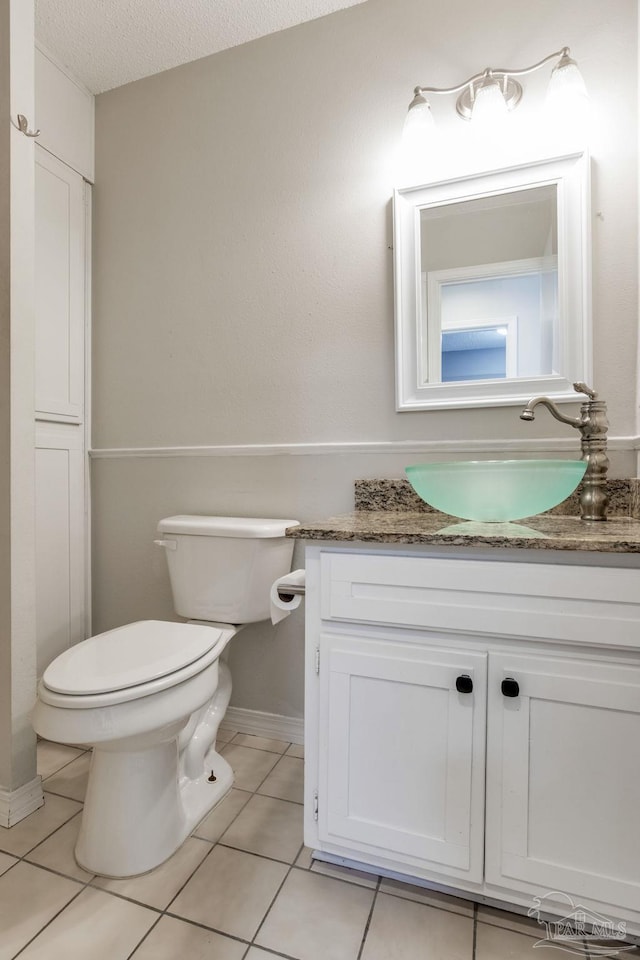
[403,47,587,146]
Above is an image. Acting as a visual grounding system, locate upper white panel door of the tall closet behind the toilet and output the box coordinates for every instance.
[35,147,85,423]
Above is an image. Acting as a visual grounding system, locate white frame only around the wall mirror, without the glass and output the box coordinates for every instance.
[393,151,593,411]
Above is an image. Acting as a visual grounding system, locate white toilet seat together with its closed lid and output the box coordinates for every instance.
[38,620,236,709]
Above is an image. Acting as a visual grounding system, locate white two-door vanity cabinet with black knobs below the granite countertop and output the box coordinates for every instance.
[305,543,640,935]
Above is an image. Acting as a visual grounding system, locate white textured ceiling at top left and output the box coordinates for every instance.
[36,0,364,93]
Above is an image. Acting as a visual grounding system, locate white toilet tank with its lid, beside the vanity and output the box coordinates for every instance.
[156,516,298,623]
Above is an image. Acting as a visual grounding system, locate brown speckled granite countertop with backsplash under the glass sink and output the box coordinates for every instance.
[287,480,640,553]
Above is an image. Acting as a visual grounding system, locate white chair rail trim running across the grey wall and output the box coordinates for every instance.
[89,436,640,460]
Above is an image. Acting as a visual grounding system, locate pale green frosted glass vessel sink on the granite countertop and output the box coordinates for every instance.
[405,460,587,523]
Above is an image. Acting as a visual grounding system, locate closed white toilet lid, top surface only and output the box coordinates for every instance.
[42,620,223,696]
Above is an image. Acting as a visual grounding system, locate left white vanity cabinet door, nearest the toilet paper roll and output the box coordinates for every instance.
[318,636,486,882]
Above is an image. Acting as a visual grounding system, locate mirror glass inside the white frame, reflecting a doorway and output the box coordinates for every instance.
[420,184,558,383]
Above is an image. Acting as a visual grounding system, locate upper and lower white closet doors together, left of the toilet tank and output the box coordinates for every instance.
[35,147,88,675]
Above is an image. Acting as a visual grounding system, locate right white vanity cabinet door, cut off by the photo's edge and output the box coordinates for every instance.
[486,654,640,910]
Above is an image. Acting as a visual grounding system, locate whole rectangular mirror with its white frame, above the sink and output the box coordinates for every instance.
[394,152,592,411]
